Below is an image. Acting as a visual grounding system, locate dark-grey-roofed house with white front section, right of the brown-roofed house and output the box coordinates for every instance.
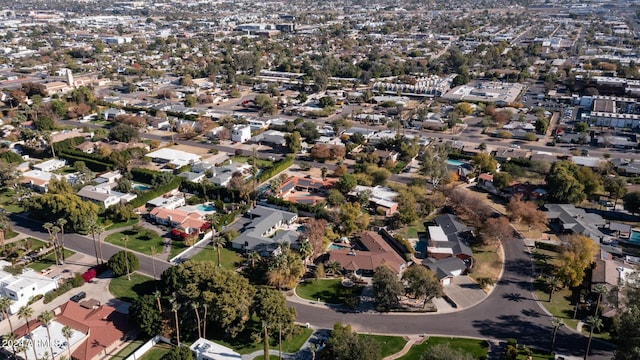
[418,214,473,265]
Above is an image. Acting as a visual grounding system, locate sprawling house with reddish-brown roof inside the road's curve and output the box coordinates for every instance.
[329,231,407,275]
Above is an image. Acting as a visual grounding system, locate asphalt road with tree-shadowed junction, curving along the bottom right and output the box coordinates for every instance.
[290,235,613,359]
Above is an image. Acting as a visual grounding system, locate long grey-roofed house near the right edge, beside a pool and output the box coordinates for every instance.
[544,204,609,244]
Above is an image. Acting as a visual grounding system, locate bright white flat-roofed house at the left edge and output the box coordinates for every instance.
[0,261,58,314]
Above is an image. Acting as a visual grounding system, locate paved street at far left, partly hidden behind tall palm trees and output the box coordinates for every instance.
[11,215,171,276]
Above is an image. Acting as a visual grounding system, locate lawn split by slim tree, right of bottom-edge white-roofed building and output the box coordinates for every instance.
[216,324,313,354]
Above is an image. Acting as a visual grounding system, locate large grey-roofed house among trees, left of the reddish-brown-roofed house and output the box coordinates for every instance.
[231,205,299,256]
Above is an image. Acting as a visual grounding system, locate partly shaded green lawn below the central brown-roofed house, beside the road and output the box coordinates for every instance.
[296,279,363,304]
